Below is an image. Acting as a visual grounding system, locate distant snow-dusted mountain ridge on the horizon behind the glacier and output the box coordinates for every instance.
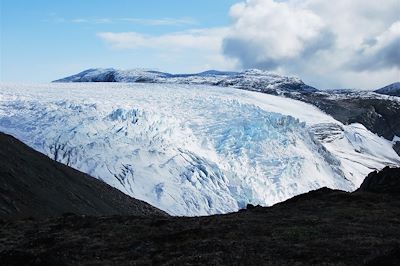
[54,68,317,94]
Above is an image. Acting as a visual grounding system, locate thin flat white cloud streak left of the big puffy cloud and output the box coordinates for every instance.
[97,28,237,72]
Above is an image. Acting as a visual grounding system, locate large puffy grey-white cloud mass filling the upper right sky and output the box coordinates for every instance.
[223,0,400,88]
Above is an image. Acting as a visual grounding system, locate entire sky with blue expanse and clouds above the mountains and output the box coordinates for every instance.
[0,0,400,89]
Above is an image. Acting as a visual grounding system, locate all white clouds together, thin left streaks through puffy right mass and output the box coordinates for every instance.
[98,0,400,88]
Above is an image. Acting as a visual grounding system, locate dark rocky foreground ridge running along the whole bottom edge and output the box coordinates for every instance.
[0,168,400,265]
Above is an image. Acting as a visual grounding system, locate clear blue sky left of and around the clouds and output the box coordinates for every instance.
[1,0,235,82]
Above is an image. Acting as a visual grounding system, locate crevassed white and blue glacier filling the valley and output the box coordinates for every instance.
[0,83,400,215]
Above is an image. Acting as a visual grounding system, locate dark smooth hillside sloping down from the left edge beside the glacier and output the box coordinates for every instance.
[0,132,166,219]
